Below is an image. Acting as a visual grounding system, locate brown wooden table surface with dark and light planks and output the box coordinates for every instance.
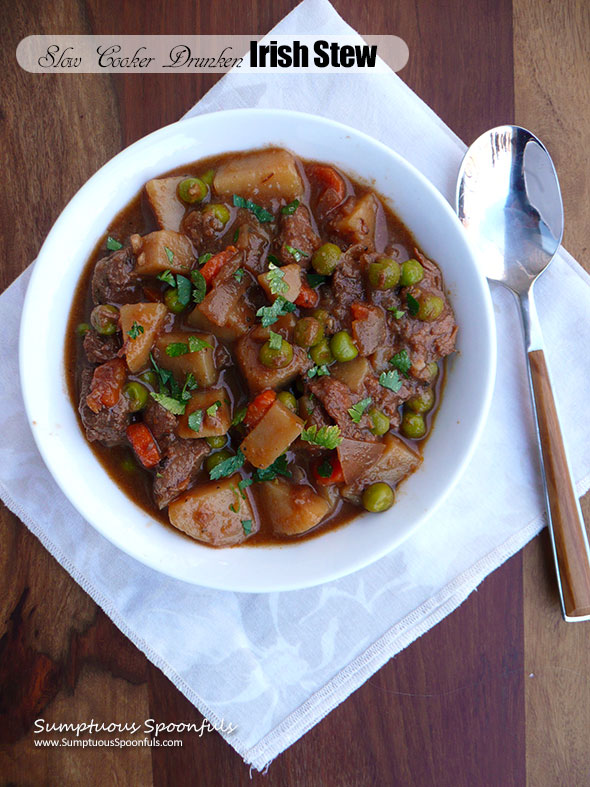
[0,0,590,787]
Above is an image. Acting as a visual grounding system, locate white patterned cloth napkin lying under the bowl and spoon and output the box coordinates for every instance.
[0,0,590,769]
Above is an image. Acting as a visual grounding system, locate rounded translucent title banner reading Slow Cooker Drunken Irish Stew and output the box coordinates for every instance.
[16,35,409,74]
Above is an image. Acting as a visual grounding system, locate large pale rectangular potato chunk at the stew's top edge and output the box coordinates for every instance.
[213,150,303,205]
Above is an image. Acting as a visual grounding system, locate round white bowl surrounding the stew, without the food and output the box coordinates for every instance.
[20,110,496,592]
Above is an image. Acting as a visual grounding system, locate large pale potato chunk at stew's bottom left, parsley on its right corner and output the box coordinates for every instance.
[168,473,260,547]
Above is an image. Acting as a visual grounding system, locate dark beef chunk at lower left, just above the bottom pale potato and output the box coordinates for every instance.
[154,438,211,508]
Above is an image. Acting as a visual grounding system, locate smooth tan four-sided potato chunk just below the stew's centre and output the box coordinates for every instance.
[240,399,304,468]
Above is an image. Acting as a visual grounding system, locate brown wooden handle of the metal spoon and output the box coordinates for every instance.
[528,350,590,618]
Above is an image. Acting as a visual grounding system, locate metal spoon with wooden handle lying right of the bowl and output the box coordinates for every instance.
[457,126,590,622]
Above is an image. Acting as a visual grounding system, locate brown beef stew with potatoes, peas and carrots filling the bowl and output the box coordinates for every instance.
[66,149,457,547]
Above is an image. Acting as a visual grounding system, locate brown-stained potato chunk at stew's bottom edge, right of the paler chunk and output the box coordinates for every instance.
[257,478,331,536]
